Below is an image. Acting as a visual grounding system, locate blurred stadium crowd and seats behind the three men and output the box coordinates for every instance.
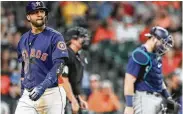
[1,1,182,114]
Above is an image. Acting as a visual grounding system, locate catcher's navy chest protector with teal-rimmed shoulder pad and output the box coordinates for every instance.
[132,48,163,91]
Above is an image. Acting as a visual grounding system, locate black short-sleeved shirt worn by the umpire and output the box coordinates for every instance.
[63,47,84,95]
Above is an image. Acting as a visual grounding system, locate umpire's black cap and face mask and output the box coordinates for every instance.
[65,27,90,49]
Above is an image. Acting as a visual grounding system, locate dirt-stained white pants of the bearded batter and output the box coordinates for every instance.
[15,87,66,114]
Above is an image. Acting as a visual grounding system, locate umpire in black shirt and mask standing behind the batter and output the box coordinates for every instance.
[62,27,90,113]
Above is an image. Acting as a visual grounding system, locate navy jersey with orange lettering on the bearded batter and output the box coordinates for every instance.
[17,27,68,89]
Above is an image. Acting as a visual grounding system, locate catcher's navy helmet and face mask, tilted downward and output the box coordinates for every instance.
[145,26,174,55]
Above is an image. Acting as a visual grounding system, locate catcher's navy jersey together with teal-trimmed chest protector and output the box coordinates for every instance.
[127,45,163,92]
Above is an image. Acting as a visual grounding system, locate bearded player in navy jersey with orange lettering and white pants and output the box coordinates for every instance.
[15,1,68,114]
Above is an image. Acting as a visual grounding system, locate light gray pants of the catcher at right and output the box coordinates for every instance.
[133,91,163,114]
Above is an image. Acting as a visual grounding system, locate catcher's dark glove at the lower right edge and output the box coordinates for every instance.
[166,99,180,114]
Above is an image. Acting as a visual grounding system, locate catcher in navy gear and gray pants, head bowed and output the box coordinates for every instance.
[124,26,177,114]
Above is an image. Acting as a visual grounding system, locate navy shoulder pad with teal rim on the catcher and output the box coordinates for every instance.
[132,48,150,65]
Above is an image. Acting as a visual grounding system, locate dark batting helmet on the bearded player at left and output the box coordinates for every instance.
[26,1,48,15]
